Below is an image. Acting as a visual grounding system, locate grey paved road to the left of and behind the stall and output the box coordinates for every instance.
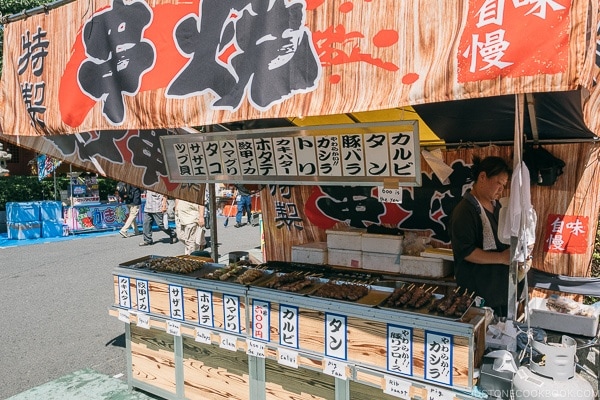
[0,218,260,399]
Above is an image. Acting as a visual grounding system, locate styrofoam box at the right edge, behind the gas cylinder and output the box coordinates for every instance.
[529,297,598,336]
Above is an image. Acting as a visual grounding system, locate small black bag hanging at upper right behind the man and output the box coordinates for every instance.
[523,145,565,186]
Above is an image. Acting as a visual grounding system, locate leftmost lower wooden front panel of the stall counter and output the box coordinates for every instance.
[130,324,176,393]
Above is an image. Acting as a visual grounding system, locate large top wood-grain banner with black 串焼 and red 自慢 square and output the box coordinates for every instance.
[0,0,600,136]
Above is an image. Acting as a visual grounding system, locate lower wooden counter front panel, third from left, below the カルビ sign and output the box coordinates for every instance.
[265,359,335,400]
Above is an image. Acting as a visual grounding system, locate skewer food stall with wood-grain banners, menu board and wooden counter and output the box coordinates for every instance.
[0,0,600,400]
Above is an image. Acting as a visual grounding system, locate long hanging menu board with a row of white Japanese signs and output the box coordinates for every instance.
[160,121,421,187]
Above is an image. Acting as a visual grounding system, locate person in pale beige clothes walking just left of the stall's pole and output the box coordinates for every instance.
[175,199,206,255]
